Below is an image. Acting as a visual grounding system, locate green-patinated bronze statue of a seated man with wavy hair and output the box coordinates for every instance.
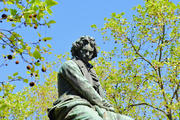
[48,36,133,120]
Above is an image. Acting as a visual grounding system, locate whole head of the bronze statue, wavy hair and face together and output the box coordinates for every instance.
[71,36,98,62]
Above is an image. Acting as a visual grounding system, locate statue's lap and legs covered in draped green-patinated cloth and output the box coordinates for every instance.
[49,99,133,120]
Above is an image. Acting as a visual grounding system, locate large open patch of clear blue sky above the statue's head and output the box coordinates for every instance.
[50,0,143,54]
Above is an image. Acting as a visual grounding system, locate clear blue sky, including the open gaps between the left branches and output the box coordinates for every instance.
[0,0,178,90]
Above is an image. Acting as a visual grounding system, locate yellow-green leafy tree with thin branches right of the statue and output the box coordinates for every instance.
[92,0,180,120]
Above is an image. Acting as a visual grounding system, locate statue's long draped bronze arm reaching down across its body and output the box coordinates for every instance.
[60,60,104,107]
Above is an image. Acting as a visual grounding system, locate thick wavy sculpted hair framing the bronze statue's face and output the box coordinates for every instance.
[71,36,98,59]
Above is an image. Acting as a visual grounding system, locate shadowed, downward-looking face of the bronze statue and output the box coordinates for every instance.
[79,42,94,62]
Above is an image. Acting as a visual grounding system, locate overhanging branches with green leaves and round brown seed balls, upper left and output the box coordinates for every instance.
[0,0,57,83]
